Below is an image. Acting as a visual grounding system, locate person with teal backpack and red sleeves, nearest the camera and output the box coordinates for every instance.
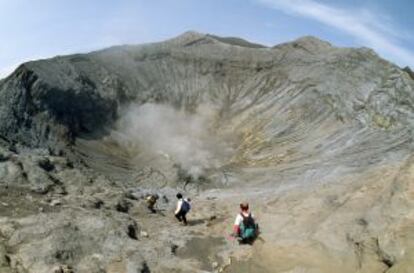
[233,202,259,243]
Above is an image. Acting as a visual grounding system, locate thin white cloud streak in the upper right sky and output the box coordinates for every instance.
[256,0,414,66]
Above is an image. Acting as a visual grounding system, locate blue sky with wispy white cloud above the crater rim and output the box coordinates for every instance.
[0,0,414,78]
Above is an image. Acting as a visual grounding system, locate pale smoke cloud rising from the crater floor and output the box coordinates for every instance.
[112,104,229,177]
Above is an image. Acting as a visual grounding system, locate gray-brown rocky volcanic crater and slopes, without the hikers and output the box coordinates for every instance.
[0,32,414,273]
